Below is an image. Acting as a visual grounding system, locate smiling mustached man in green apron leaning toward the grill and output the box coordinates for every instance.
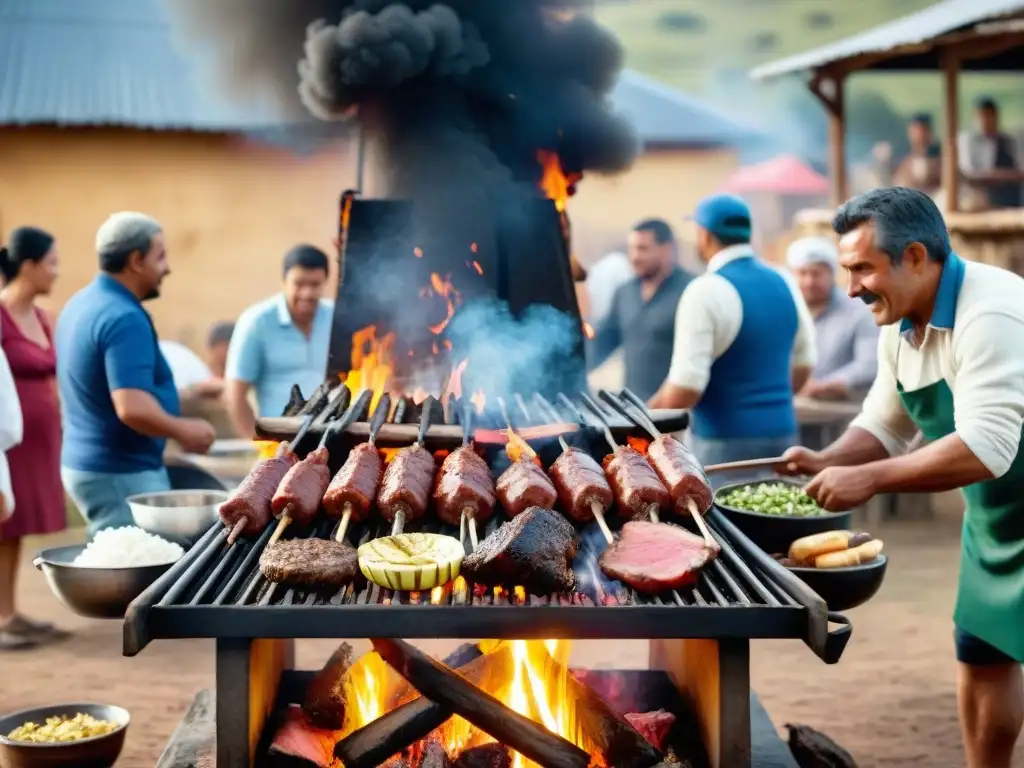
[784,187,1024,768]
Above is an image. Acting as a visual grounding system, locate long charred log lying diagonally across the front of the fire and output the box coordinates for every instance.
[371,638,590,768]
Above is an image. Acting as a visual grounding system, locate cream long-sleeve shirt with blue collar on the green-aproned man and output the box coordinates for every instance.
[851,257,1024,477]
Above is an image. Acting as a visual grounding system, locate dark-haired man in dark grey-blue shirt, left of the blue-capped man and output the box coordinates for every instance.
[587,219,692,400]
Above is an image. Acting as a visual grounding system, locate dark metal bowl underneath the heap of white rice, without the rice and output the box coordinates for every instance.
[34,544,173,622]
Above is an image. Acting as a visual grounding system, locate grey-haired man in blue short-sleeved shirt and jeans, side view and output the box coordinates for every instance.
[54,211,214,537]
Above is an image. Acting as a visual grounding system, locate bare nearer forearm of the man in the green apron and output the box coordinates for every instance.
[865,434,992,494]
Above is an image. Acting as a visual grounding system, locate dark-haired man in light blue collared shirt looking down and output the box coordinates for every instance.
[224,245,334,438]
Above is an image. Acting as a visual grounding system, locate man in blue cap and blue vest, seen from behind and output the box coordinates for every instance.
[650,195,815,464]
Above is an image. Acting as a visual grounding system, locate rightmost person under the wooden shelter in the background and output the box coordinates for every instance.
[957,96,1024,208]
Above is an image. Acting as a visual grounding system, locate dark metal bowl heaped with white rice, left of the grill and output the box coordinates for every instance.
[33,526,184,618]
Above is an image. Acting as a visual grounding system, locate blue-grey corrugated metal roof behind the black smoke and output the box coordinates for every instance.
[0,0,757,144]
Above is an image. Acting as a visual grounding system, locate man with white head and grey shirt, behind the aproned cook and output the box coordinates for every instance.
[786,238,879,399]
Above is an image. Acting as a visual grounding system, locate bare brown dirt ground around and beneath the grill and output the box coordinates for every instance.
[0,505,1024,768]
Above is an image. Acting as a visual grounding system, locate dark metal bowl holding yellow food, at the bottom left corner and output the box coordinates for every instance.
[0,703,131,768]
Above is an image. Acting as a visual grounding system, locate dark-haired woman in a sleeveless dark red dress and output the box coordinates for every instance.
[0,226,67,651]
